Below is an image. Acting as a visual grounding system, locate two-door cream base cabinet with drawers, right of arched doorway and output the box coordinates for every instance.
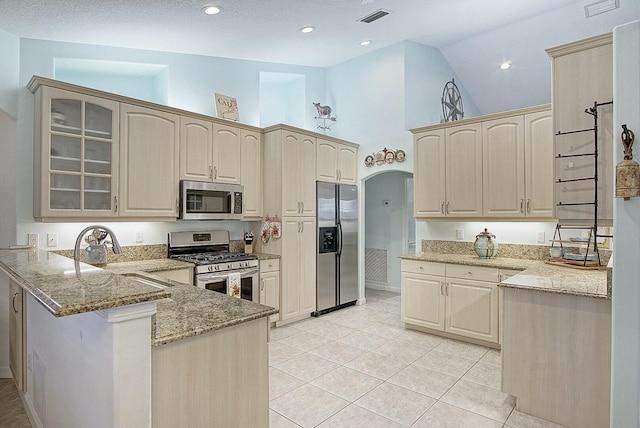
[401,260,500,346]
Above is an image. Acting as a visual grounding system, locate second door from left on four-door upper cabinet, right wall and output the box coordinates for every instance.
[445,123,482,217]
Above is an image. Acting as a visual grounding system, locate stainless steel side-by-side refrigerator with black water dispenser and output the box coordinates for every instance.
[312,181,358,316]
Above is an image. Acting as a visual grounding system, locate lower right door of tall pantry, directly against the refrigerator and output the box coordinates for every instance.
[298,217,317,315]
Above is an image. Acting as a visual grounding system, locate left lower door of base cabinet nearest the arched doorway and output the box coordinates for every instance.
[400,272,445,331]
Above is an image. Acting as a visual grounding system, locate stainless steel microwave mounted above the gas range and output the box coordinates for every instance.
[178,180,244,220]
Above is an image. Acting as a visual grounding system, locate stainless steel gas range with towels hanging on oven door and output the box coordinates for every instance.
[168,230,260,302]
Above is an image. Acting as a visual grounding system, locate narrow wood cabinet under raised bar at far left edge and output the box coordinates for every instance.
[9,282,27,391]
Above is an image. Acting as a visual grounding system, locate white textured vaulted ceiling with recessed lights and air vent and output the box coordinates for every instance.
[0,0,640,112]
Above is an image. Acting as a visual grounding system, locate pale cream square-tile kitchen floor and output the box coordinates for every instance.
[269,289,559,428]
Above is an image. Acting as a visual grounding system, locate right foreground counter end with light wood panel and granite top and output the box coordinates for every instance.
[501,265,611,428]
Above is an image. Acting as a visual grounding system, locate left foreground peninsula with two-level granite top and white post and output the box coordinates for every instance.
[0,249,276,427]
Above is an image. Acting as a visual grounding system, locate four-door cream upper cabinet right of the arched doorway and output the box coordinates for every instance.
[412,106,553,218]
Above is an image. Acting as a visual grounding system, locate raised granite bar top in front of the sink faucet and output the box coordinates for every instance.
[0,249,170,317]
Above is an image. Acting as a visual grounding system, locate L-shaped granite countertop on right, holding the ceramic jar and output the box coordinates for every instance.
[401,253,611,299]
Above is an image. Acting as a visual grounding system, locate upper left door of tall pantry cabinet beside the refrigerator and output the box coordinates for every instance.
[282,132,304,216]
